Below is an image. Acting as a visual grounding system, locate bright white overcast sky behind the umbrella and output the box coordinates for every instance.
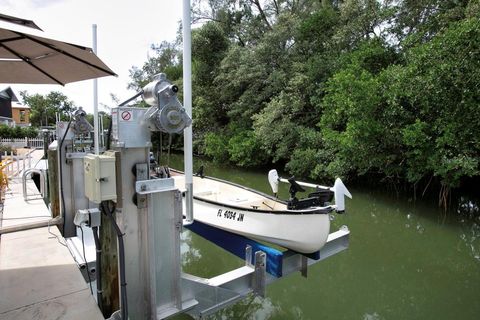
[0,0,182,113]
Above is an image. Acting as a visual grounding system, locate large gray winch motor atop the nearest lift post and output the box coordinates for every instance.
[142,73,192,133]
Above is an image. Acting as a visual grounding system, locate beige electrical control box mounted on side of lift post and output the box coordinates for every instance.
[83,151,117,203]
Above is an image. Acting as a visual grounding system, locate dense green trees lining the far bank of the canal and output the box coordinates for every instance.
[131,0,480,196]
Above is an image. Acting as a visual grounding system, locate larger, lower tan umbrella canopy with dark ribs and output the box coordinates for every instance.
[0,24,116,85]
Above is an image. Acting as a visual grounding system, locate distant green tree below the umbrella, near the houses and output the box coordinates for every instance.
[20,91,75,127]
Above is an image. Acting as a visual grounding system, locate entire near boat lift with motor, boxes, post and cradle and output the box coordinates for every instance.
[69,71,350,319]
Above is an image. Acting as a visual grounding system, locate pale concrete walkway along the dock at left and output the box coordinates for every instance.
[0,152,103,320]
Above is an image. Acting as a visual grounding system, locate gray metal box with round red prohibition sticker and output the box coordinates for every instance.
[112,107,152,148]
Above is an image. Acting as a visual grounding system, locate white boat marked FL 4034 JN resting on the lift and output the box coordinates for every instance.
[172,170,351,253]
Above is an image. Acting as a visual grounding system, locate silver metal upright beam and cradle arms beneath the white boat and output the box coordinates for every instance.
[135,178,350,319]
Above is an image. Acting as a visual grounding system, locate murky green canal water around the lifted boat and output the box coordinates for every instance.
[166,155,480,320]
